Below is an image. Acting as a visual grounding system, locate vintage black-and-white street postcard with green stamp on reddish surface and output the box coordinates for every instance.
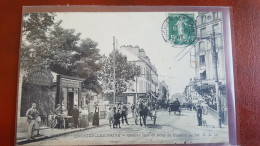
[16,7,235,145]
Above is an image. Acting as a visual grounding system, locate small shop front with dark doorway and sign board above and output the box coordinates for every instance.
[55,75,84,116]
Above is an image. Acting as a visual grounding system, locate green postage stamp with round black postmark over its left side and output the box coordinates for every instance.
[161,13,197,47]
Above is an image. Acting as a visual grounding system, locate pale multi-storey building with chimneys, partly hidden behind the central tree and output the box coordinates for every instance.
[119,45,158,103]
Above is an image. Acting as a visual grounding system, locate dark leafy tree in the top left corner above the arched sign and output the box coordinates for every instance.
[20,13,61,71]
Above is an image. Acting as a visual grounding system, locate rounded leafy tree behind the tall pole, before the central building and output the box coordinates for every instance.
[99,50,141,96]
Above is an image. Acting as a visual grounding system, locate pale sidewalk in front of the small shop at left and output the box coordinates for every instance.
[16,119,108,145]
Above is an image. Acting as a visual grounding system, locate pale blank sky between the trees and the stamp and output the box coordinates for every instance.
[57,12,195,96]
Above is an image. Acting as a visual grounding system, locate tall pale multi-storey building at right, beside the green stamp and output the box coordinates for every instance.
[195,12,226,82]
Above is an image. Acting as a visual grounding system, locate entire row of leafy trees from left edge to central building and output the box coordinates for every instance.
[20,13,140,95]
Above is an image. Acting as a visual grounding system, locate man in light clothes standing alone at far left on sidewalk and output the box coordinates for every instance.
[26,103,40,139]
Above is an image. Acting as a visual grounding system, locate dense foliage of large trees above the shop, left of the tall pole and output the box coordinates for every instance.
[20,13,101,92]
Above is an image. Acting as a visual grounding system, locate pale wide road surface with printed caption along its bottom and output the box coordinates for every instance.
[23,110,228,145]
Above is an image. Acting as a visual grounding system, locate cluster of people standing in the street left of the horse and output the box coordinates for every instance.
[107,102,129,128]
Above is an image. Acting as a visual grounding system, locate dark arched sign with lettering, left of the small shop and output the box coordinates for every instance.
[28,67,53,86]
